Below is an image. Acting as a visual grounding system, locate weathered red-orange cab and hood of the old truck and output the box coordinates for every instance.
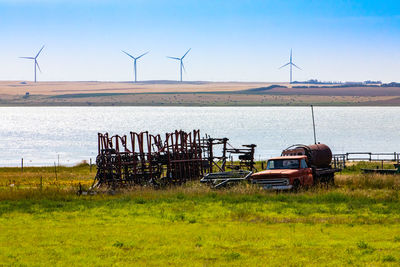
[250,155,314,190]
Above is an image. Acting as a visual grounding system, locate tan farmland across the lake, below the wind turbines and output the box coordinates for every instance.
[0,81,400,106]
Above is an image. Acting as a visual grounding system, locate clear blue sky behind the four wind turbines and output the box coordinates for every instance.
[0,0,400,82]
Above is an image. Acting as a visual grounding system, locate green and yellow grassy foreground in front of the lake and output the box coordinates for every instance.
[0,166,400,266]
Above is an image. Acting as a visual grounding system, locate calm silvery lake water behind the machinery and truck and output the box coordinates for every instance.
[0,107,400,166]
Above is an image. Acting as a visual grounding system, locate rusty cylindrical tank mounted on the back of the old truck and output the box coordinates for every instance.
[282,144,332,168]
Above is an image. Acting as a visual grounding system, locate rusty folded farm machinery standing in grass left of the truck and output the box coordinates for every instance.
[92,130,256,189]
